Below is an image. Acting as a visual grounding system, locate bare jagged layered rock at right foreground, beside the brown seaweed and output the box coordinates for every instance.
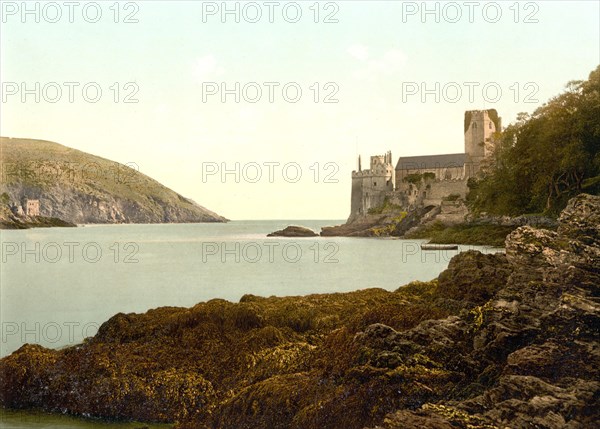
[366,195,600,429]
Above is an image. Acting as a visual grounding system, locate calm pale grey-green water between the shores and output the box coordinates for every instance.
[0,220,496,429]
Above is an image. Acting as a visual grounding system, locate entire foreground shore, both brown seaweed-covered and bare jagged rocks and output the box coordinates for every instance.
[0,195,600,429]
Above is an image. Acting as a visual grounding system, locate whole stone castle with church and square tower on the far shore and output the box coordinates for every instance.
[349,109,502,221]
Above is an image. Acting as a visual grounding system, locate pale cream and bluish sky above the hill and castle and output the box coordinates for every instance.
[0,1,600,220]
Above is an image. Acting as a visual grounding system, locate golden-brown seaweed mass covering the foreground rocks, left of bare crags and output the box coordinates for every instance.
[0,284,447,428]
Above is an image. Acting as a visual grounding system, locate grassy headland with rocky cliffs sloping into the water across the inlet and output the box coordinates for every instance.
[0,137,226,224]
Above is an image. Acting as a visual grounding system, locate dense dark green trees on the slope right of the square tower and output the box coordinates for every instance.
[467,66,600,215]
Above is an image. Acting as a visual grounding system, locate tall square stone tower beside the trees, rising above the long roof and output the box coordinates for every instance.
[464,109,502,177]
